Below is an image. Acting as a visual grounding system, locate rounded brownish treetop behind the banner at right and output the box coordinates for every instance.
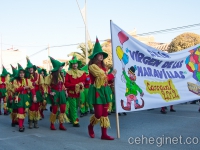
[168,33,200,53]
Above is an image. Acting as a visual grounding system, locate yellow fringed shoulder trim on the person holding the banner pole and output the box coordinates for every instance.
[89,64,108,89]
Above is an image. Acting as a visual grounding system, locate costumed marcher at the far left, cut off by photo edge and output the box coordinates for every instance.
[0,66,10,115]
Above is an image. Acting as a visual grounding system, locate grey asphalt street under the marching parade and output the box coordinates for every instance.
[0,103,200,150]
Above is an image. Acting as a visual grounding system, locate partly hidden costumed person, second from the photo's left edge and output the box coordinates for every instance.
[7,65,18,127]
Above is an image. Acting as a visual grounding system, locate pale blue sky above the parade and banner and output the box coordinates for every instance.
[0,0,200,63]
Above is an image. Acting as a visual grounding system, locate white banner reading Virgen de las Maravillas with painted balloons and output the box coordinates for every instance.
[111,22,200,112]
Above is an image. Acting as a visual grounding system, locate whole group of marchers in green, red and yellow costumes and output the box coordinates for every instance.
[0,39,116,140]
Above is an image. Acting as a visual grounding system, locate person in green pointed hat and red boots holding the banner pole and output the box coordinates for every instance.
[88,39,116,140]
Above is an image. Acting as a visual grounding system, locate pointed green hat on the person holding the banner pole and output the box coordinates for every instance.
[88,38,108,59]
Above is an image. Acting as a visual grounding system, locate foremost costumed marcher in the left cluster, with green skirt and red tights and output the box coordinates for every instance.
[13,64,37,132]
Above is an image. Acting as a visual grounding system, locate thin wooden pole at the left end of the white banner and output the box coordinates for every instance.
[110,20,120,139]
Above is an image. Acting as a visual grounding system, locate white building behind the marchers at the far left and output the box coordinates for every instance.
[0,50,26,73]
